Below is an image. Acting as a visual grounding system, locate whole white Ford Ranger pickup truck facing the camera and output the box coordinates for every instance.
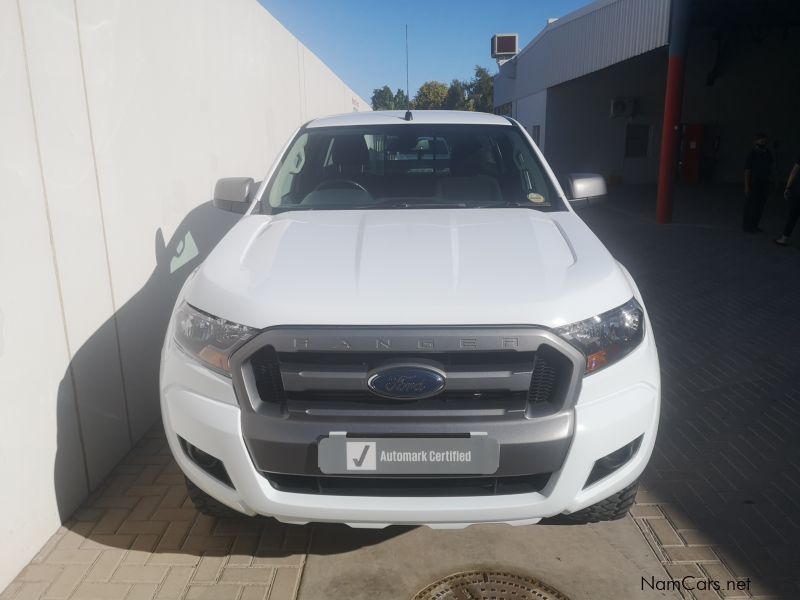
[161,111,660,527]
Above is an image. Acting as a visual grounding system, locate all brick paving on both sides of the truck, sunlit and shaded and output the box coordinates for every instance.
[0,188,800,600]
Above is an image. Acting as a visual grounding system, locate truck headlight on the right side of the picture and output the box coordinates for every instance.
[555,299,644,375]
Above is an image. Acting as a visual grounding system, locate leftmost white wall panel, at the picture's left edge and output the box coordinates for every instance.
[0,0,87,589]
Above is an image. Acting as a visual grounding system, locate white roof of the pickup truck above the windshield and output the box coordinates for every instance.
[306,109,511,127]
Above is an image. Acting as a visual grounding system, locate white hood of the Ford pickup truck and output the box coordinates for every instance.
[186,208,633,328]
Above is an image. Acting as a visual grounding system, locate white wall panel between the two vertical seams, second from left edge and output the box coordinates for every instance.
[20,0,131,486]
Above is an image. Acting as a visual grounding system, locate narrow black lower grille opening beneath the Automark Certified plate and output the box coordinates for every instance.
[262,473,551,497]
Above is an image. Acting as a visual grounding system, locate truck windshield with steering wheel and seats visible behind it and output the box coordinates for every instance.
[262,123,565,213]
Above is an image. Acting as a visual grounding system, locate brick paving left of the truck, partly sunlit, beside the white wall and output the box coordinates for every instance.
[0,424,310,600]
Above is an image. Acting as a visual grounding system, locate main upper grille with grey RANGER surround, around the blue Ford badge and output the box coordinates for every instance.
[241,327,583,417]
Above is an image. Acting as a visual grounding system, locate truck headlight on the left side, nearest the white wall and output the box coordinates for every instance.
[174,302,258,377]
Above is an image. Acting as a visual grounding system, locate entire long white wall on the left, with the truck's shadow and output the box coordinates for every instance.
[0,0,368,589]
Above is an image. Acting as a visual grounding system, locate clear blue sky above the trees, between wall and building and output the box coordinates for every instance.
[259,0,589,101]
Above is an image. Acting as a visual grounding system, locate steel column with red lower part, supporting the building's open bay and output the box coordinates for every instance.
[656,0,689,223]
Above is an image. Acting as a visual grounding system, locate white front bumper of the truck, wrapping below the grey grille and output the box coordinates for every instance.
[161,324,660,527]
